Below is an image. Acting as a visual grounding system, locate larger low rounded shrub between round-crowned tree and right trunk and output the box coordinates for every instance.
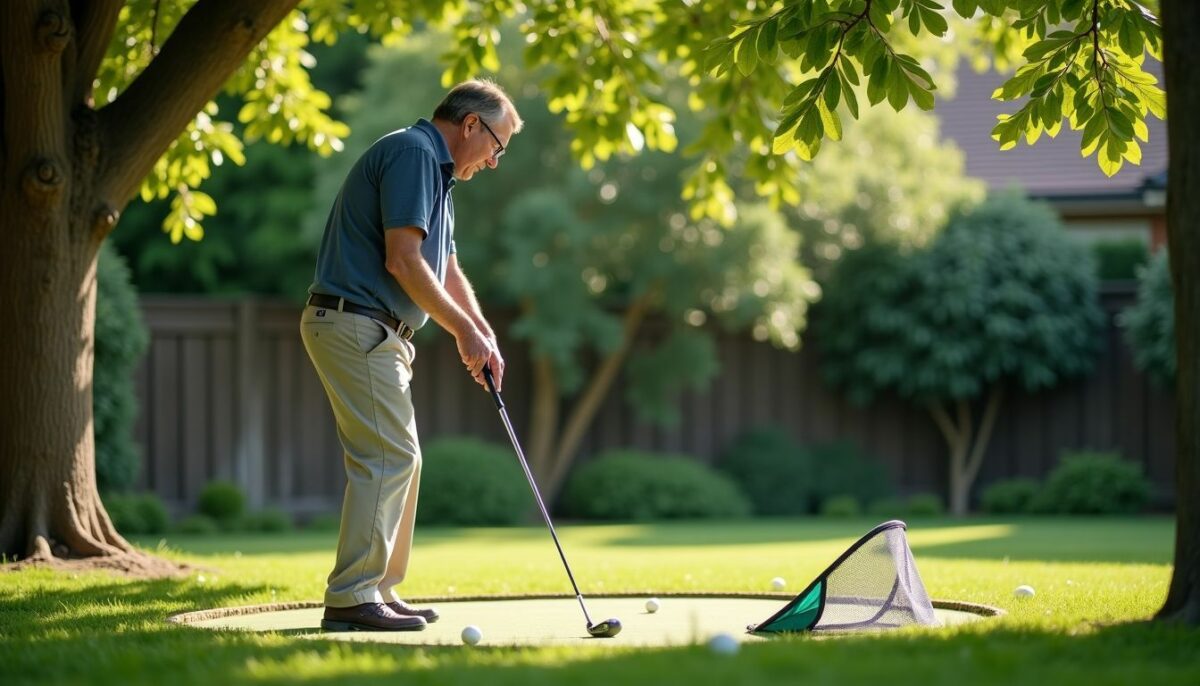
[1033,452,1150,515]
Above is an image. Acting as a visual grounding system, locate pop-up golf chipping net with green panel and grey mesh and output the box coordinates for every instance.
[746,519,941,633]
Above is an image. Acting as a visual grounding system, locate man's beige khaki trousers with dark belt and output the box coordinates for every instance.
[300,306,421,607]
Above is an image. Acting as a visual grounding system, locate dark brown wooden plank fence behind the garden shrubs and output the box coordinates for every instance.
[136,285,1174,513]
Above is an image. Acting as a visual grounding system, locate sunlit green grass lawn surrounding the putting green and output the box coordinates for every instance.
[0,518,1200,686]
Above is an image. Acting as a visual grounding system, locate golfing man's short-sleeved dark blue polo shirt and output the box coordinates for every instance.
[308,119,455,329]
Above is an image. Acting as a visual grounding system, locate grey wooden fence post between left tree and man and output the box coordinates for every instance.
[235,297,266,510]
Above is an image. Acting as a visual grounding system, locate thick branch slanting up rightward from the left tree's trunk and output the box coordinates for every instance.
[100,0,299,207]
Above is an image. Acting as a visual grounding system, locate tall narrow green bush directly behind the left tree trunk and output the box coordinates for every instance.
[91,245,150,493]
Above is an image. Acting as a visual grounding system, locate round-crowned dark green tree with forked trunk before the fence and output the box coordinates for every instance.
[815,192,1104,516]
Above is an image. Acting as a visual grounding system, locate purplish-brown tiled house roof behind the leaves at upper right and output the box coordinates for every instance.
[934,60,1166,199]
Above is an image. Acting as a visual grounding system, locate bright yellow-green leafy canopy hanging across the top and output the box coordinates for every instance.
[105,0,1164,241]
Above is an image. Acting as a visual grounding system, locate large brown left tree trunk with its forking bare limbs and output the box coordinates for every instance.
[0,0,298,560]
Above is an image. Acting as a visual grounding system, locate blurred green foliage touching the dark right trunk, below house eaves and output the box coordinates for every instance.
[1117,249,1177,387]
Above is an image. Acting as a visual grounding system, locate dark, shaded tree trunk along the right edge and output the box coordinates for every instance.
[1158,0,1200,626]
